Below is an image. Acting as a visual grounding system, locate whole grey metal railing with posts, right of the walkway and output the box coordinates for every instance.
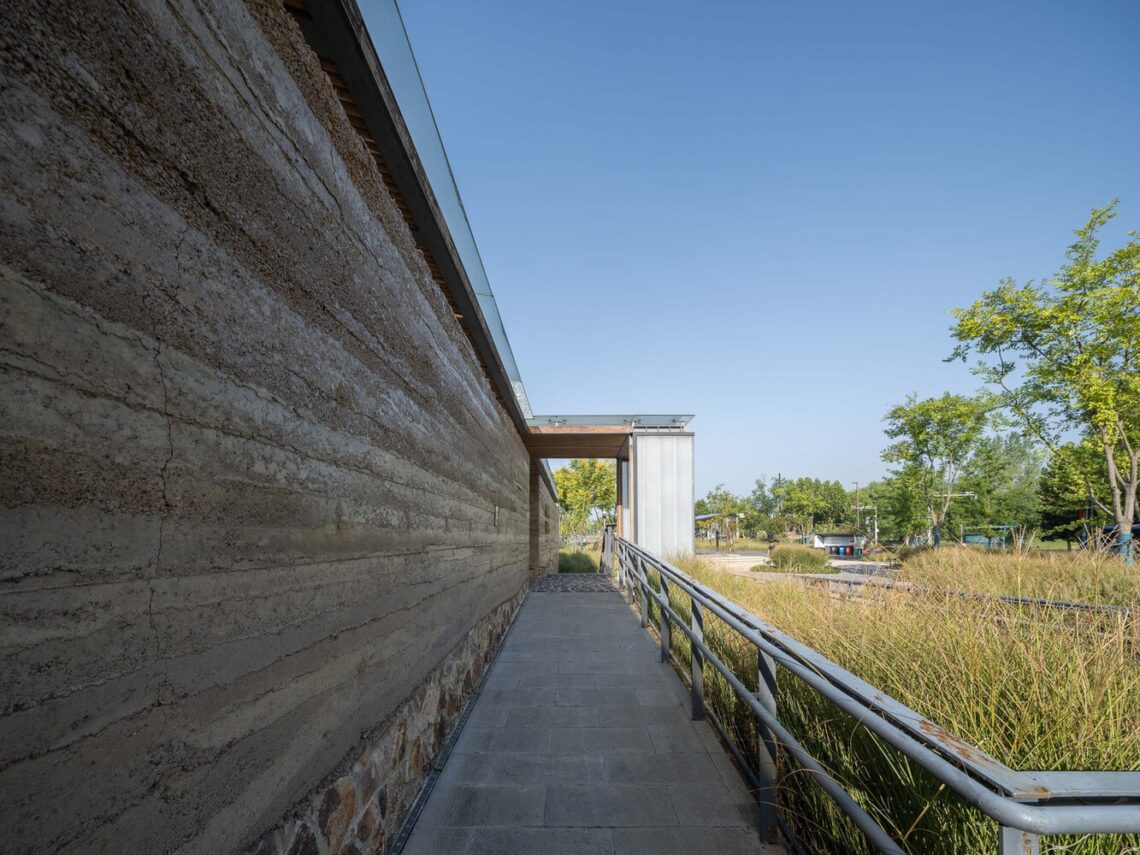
[602,529,1140,855]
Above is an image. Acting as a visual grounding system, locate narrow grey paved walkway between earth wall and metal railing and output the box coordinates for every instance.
[404,577,783,855]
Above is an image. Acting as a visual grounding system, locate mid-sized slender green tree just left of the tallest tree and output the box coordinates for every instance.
[882,392,987,544]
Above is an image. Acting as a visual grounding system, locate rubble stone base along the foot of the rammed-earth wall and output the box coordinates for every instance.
[245,592,526,855]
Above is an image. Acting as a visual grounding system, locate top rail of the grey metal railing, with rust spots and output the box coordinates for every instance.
[614,537,1140,833]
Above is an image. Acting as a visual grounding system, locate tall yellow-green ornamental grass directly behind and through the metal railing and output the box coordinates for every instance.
[652,551,1140,855]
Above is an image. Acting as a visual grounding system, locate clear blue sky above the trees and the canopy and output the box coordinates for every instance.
[376,0,1140,496]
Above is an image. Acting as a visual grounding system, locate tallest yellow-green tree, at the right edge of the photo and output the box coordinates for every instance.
[950,202,1140,555]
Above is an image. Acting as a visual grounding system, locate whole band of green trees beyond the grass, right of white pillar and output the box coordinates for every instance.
[697,202,1140,563]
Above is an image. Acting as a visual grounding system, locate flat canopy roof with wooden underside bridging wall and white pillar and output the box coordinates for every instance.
[523,415,692,458]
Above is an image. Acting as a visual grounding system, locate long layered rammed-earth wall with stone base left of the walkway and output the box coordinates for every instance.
[0,0,551,853]
